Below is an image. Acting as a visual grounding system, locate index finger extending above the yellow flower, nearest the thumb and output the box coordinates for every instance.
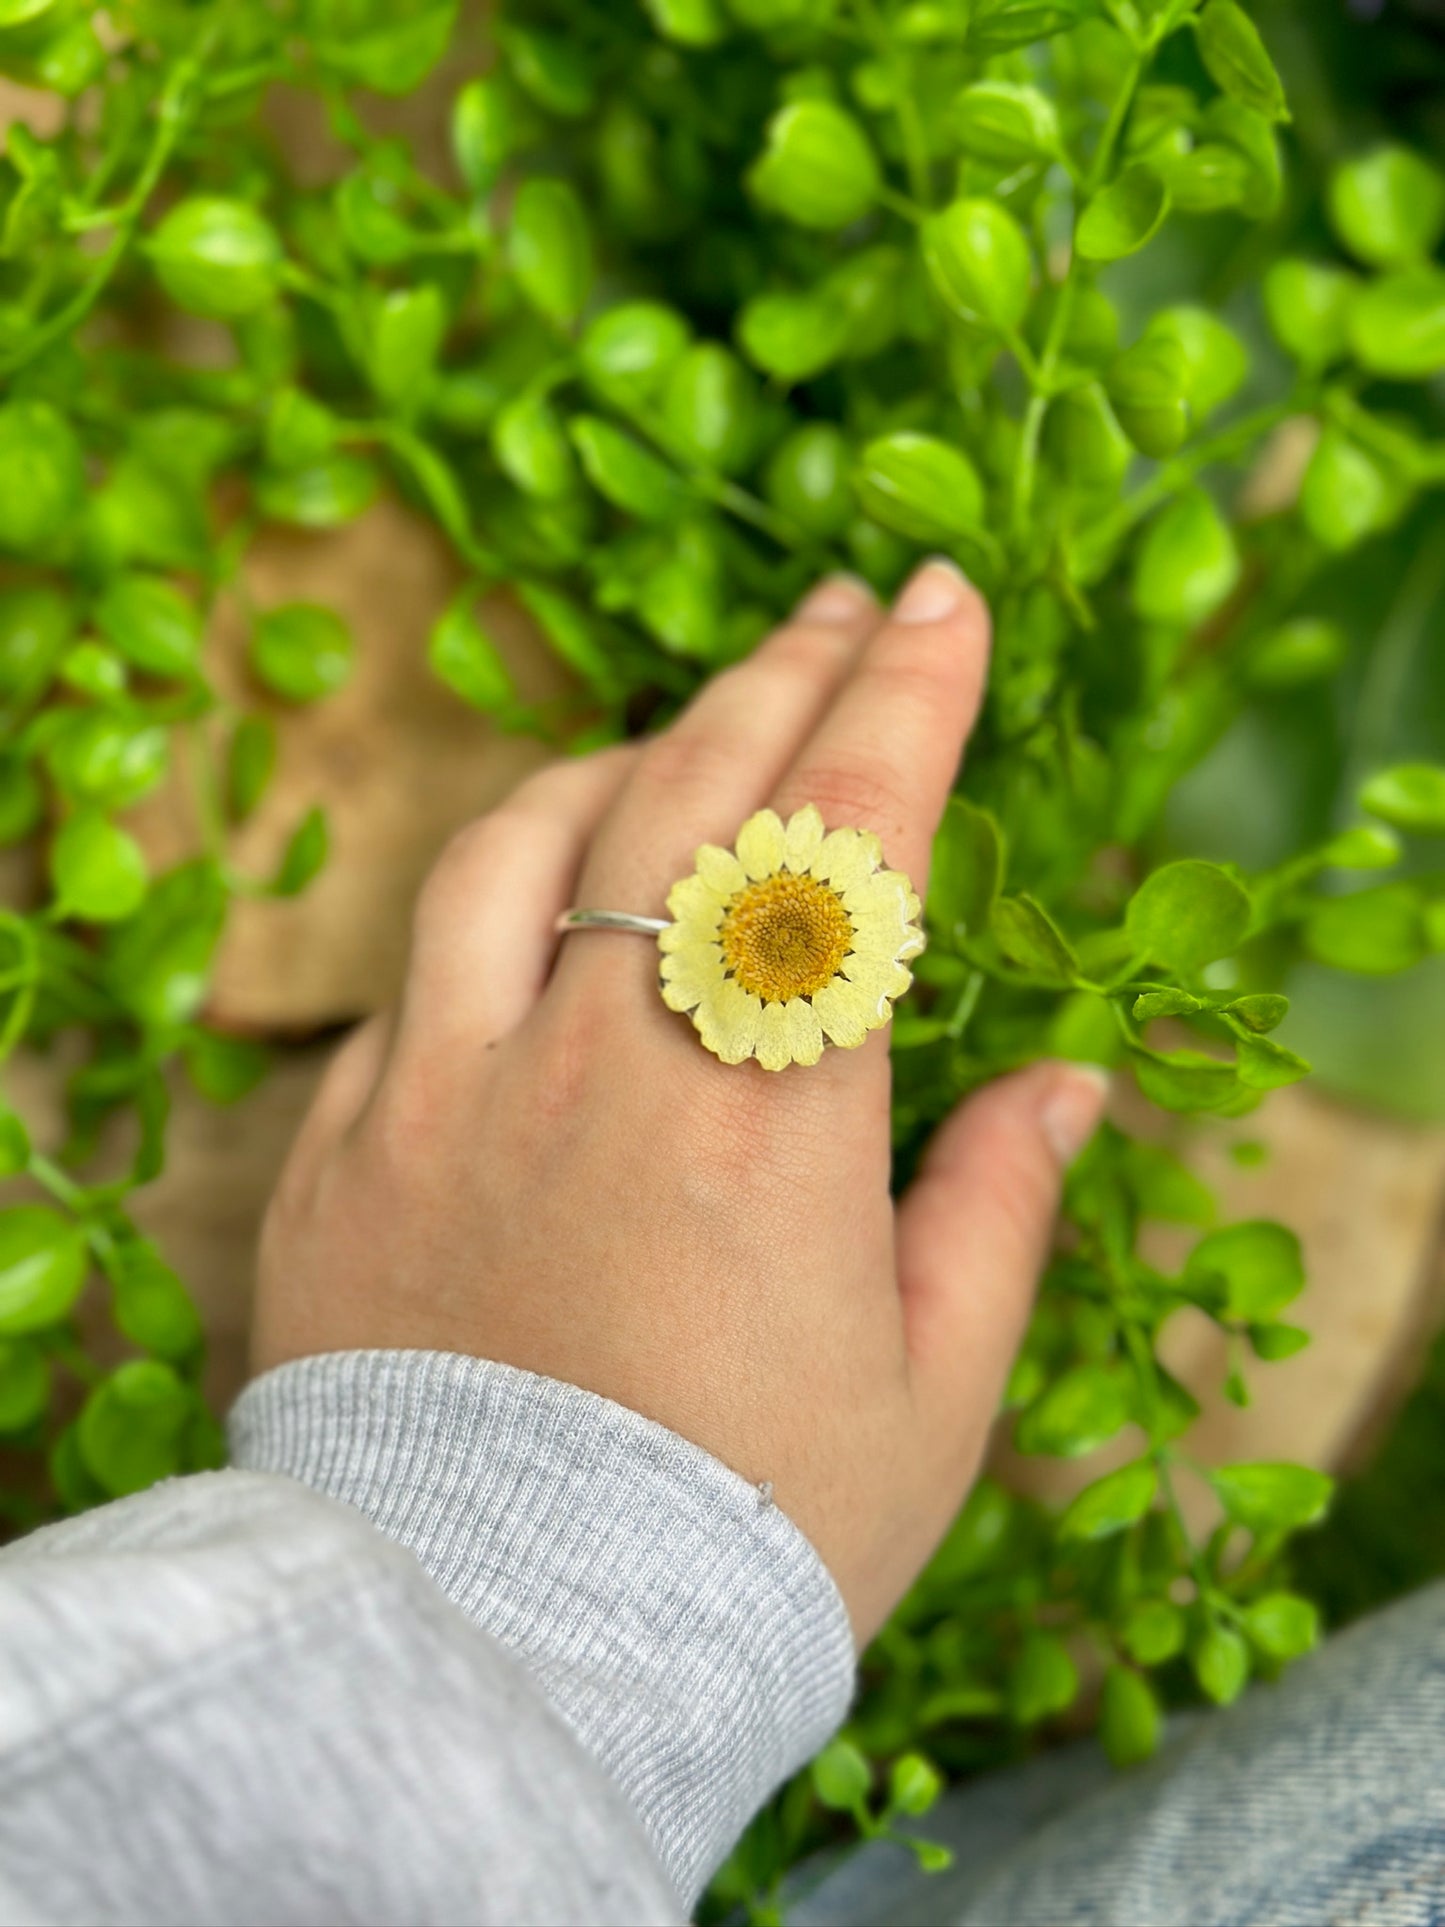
[773,559,988,896]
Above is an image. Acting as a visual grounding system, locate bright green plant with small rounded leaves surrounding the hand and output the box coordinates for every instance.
[0,0,1445,1917]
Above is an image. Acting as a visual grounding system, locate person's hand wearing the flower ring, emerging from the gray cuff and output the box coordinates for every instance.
[254,563,1104,1644]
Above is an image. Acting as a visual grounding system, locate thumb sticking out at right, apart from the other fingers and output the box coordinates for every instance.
[896,1064,1108,1443]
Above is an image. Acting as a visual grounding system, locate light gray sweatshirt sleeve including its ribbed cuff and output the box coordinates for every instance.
[0,1351,854,1927]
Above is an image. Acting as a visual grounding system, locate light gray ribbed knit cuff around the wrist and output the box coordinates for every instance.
[229,1351,854,1910]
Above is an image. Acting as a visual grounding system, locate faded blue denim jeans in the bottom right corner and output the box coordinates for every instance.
[788,1586,1445,1927]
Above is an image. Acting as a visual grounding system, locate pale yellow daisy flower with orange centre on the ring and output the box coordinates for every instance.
[657,804,925,1071]
